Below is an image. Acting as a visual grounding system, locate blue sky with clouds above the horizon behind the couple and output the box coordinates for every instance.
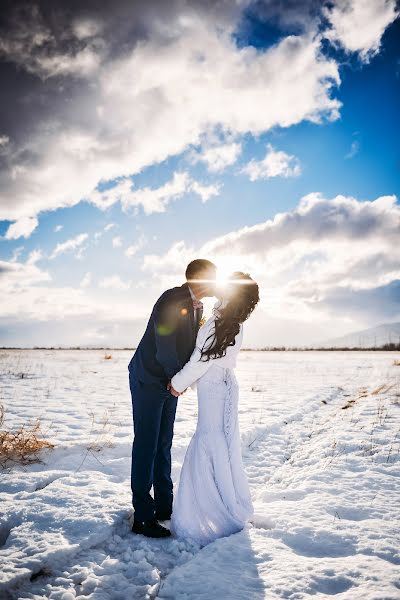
[0,0,400,347]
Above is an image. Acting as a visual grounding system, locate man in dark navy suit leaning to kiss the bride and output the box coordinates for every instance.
[128,259,216,537]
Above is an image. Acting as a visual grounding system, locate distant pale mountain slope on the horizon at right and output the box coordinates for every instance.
[318,323,400,348]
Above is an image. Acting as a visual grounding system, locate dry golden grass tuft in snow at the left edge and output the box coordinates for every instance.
[0,404,54,468]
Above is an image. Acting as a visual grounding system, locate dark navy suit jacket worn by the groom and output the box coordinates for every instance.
[128,283,202,386]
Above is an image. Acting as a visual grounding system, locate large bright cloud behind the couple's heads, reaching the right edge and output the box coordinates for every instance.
[143,193,400,326]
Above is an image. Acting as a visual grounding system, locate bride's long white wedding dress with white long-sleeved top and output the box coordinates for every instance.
[171,301,253,546]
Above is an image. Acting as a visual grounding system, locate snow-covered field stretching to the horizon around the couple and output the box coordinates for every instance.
[0,350,400,600]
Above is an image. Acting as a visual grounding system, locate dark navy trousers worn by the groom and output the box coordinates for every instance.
[129,374,178,521]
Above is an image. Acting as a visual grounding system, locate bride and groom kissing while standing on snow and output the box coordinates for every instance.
[128,259,259,546]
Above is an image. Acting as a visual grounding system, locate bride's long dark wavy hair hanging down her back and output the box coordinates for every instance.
[200,271,260,361]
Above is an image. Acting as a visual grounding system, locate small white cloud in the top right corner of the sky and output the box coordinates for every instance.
[323,0,399,62]
